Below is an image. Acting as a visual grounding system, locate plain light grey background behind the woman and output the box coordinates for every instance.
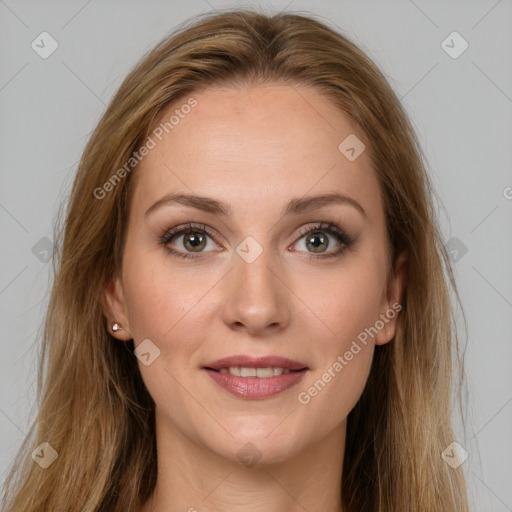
[0,0,512,512]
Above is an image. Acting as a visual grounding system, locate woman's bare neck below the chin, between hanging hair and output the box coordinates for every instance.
[141,412,346,512]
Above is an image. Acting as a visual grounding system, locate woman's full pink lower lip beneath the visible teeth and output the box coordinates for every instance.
[205,369,307,400]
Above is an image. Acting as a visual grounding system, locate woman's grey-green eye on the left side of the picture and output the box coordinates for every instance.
[161,223,218,258]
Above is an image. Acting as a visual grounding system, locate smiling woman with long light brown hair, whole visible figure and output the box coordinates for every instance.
[3,11,468,512]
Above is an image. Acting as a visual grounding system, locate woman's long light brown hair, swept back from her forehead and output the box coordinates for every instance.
[2,10,468,512]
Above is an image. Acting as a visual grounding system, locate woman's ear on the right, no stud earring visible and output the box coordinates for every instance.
[375,251,407,345]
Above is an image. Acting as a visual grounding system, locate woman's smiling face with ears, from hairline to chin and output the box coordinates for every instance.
[107,84,403,462]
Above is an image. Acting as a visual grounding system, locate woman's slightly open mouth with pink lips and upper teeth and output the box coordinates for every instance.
[202,356,309,400]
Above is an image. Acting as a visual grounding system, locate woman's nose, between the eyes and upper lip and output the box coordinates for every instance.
[222,244,291,336]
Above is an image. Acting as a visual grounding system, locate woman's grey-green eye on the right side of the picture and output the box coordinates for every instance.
[294,222,354,258]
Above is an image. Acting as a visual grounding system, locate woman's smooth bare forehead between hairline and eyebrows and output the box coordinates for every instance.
[133,83,380,218]
